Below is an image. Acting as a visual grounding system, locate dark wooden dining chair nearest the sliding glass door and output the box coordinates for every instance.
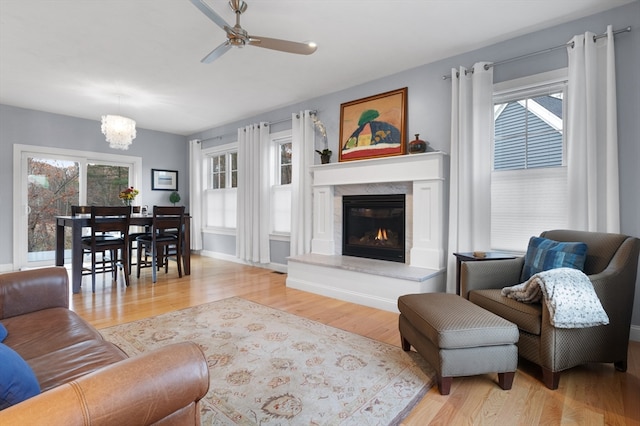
[82,206,131,293]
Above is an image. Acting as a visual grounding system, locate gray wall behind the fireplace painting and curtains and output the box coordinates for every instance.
[193,2,640,326]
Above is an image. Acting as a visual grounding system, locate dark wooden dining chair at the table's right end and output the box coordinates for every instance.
[137,206,184,283]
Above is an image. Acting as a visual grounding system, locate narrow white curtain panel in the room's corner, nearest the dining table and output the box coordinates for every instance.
[189,139,204,250]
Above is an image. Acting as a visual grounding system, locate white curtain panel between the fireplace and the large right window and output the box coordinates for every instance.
[447,62,493,293]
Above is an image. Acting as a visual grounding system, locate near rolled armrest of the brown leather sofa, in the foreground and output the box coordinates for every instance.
[0,342,209,426]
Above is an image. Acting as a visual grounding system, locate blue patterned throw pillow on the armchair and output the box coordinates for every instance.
[520,237,587,282]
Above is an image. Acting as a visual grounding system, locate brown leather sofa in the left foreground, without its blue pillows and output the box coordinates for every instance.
[0,267,209,426]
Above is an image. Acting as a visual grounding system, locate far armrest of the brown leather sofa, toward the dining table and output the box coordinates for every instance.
[0,266,69,319]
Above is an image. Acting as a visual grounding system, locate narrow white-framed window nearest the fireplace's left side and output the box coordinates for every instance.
[271,131,292,235]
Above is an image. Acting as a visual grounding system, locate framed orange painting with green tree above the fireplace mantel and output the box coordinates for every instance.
[339,87,407,161]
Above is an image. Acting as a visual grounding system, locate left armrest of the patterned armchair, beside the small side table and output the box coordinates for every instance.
[460,257,524,299]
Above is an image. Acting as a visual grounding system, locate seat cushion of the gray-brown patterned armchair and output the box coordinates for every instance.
[469,289,542,336]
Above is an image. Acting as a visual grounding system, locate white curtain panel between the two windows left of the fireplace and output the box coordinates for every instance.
[235,123,270,263]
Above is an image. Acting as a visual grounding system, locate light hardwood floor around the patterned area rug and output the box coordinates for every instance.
[71,256,640,426]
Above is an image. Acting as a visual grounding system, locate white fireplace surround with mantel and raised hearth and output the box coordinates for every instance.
[287,152,448,312]
